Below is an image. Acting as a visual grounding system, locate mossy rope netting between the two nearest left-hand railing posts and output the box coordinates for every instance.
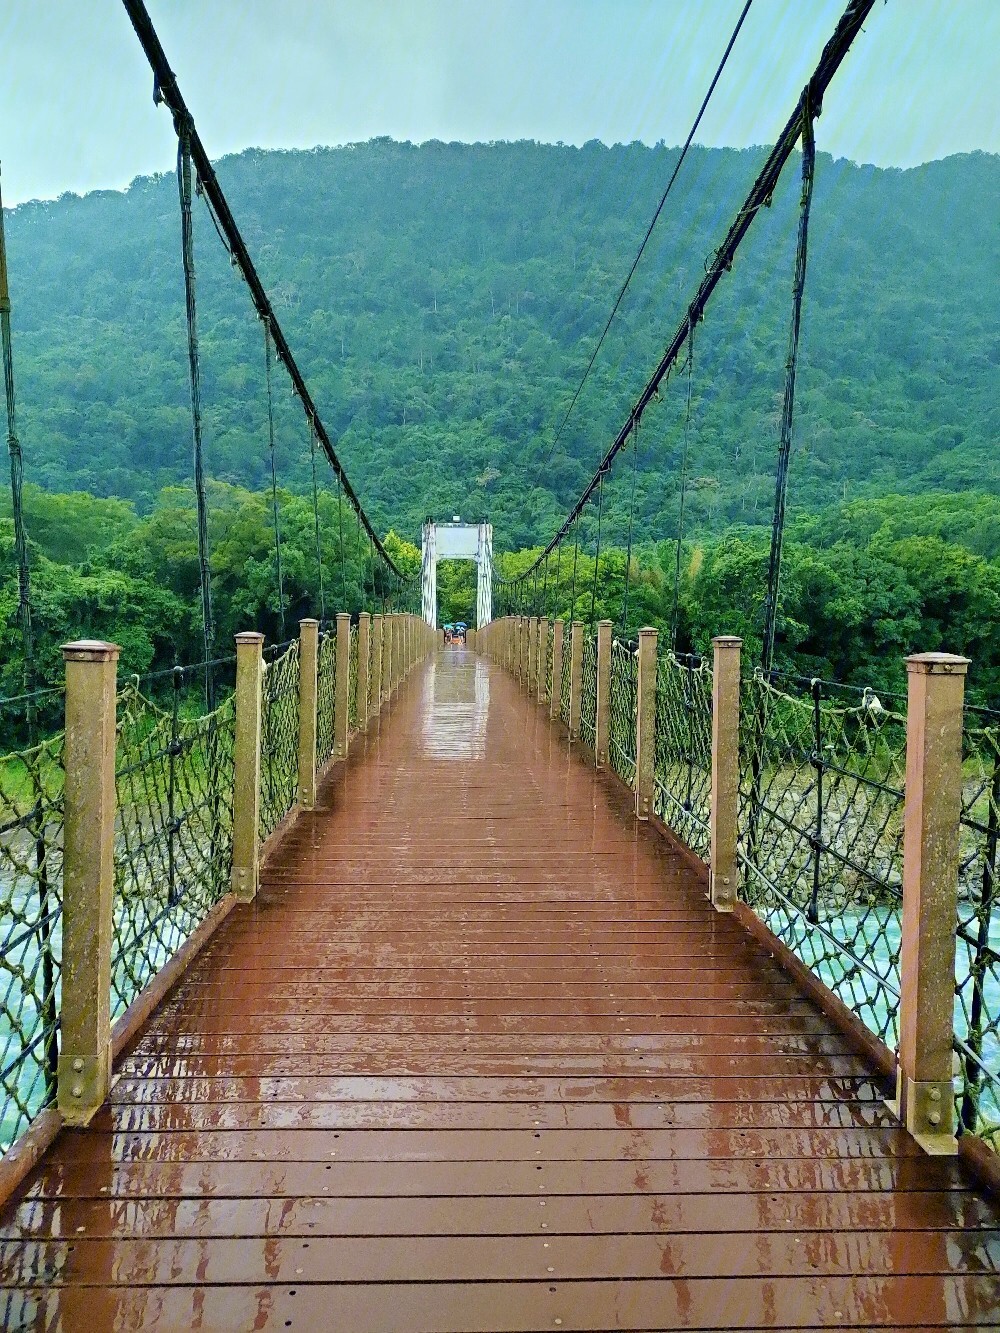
[111,682,236,1016]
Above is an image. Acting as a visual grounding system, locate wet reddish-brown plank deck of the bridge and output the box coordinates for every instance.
[0,651,1000,1333]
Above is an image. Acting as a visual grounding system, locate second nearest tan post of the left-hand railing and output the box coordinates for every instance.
[231,632,264,902]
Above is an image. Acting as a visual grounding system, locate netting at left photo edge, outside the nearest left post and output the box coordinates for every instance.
[0,734,64,1152]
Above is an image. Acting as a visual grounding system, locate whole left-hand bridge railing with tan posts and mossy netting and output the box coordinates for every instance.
[0,613,435,1173]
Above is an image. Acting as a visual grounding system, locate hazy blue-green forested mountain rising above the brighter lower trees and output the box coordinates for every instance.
[7,140,1000,549]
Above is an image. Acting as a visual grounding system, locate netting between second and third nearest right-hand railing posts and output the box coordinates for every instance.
[653,652,712,860]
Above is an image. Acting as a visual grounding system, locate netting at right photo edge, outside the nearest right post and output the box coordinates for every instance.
[955,708,1000,1150]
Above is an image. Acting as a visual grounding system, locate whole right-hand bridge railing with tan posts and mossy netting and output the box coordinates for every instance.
[480,617,1000,1178]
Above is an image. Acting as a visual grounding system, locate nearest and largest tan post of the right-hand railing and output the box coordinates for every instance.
[896,653,969,1153]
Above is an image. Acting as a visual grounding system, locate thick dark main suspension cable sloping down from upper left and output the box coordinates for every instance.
[121,0,418,579]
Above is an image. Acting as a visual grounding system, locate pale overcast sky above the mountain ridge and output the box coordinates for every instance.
[0,0,1000,205]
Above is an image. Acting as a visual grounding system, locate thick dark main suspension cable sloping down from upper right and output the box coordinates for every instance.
[509,0,876,589]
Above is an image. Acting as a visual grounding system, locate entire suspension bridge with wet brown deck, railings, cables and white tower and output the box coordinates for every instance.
[0,0,1000,1330]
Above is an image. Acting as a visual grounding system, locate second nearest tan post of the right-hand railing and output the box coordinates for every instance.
[708,635,743,912]
